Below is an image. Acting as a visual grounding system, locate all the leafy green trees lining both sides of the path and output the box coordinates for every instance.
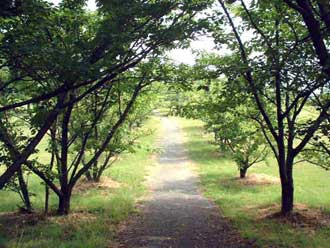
[0,0,330,215]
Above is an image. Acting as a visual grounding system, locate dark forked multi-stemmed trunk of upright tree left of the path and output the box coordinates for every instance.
[3,67,146,215]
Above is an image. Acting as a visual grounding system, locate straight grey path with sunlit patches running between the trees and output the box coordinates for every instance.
[119,117,254,248]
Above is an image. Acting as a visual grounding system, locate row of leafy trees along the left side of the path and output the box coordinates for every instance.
[0,0,213,214]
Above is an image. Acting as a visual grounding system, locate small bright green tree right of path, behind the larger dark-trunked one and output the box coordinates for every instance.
[165,60,268,178]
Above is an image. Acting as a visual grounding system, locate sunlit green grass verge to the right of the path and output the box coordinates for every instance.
[177,118,330,248]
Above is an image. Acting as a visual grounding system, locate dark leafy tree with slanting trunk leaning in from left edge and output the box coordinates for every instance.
[0,0,211,189]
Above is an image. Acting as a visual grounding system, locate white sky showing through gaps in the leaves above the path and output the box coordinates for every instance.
[46,0,218,65]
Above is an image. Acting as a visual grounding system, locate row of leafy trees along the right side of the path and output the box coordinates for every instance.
[169,0,330,215]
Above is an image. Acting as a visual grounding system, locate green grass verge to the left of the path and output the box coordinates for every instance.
[0,118,159,248]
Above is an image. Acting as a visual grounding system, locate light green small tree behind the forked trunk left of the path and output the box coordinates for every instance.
[80,79,155,182]
